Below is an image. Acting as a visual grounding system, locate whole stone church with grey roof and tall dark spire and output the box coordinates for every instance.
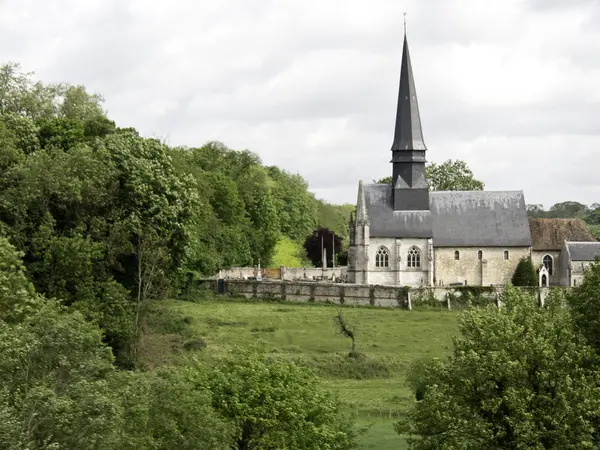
[347,34,600,287]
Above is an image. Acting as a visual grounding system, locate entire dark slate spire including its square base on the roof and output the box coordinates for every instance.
[392,22,429,211]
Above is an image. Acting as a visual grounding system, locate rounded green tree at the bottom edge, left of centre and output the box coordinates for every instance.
[202,348,356,450]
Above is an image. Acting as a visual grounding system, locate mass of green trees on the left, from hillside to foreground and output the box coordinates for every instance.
[0,63,355,450]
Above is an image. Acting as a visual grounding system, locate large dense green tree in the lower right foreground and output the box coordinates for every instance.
[396,287,600,450]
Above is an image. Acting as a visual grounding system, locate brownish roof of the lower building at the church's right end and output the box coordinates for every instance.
[529,218,596,250]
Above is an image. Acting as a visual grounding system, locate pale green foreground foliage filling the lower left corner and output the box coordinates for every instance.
[0,239,354,450]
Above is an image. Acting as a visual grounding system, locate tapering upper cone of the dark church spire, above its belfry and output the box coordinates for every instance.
[392,22,426,151]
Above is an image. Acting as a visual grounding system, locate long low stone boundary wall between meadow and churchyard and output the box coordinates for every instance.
[199,280,553,309]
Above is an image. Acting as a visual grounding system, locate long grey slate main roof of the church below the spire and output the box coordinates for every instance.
[364,184,531,247]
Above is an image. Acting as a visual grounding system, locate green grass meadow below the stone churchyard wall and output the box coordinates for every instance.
[142,299,457,450]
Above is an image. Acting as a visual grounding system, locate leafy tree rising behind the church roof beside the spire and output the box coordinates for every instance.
[377,159,485,191]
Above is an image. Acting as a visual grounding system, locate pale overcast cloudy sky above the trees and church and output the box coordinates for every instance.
[0,0,600,207]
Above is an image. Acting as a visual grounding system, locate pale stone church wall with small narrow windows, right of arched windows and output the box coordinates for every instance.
[434,247,529,286]
